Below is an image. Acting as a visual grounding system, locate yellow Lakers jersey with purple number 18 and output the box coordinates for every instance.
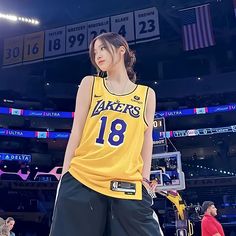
[69,77,148,200]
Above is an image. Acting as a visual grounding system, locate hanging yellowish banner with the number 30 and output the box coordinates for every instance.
[3,36,24,65]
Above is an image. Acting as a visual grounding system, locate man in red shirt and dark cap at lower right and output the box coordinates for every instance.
[201,201,225,236]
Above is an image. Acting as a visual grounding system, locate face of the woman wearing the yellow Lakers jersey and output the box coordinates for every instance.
[94,39,121,71]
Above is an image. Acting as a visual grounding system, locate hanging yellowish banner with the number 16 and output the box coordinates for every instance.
[23,31,44,62]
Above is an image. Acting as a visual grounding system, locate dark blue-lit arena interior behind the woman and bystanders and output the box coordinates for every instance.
[0,0,236,236]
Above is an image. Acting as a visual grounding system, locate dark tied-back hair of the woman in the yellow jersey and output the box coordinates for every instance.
[89,32,136,83]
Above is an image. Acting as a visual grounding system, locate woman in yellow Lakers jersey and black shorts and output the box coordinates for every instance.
[50,33,163,236]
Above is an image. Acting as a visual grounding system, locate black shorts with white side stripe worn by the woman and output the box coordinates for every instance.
[50,172,163,236]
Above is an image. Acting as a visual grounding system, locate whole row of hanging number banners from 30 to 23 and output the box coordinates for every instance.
[3,7,160,66]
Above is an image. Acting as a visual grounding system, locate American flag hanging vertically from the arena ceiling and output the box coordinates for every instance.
[180,4,215,51]
